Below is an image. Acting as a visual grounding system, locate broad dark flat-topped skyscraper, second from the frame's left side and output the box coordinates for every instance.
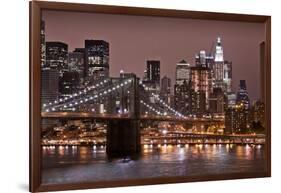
[46,42,68,76]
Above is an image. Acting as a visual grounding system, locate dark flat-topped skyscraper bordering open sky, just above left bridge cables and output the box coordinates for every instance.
[85,40,109,81]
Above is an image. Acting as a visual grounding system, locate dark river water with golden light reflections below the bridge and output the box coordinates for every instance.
[42,144,264,184]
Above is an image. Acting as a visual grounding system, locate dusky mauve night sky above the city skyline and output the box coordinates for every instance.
[43,11,265,101]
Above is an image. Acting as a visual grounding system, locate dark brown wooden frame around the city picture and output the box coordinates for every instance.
[29,1,271,192]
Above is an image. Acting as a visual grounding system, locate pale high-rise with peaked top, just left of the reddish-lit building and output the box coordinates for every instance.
[176,60,191,85]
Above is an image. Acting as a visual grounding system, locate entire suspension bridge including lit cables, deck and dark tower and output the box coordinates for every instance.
[41,74,224,156]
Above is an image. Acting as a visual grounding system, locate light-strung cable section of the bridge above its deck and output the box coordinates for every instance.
[42,77,185,118]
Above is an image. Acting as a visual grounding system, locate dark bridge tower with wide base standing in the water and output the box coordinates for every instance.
[106,75,141,158]
